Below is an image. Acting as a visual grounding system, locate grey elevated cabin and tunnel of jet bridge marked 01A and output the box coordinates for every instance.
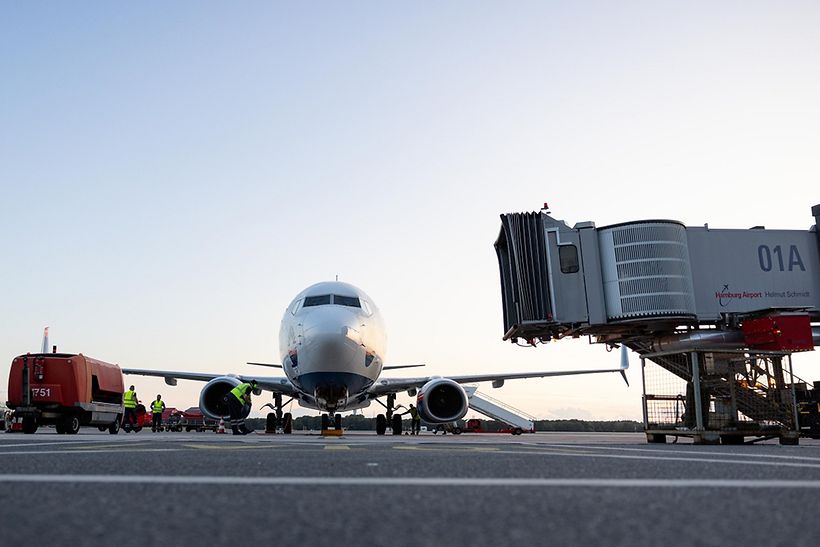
[495,205,820,341]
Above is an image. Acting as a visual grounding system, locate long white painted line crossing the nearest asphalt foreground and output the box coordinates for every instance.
[0,474,820,489]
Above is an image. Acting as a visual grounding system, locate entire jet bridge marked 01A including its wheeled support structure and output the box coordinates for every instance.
[495,205,820,443]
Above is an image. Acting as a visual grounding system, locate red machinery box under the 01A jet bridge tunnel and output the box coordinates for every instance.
[743,315,814,351]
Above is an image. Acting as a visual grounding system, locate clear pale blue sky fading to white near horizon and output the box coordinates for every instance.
[0,1,820,419]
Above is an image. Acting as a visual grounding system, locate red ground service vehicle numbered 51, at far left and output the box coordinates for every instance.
[7,354,123,434]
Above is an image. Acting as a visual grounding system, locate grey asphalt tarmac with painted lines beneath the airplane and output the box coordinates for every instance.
[0,429,820,547]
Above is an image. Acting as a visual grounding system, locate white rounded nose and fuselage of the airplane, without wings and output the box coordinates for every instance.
[279,281,387,413]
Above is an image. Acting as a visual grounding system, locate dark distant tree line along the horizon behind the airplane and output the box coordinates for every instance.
[247,414,643,433]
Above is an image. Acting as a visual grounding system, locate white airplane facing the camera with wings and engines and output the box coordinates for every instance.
[123,281,629,435]
